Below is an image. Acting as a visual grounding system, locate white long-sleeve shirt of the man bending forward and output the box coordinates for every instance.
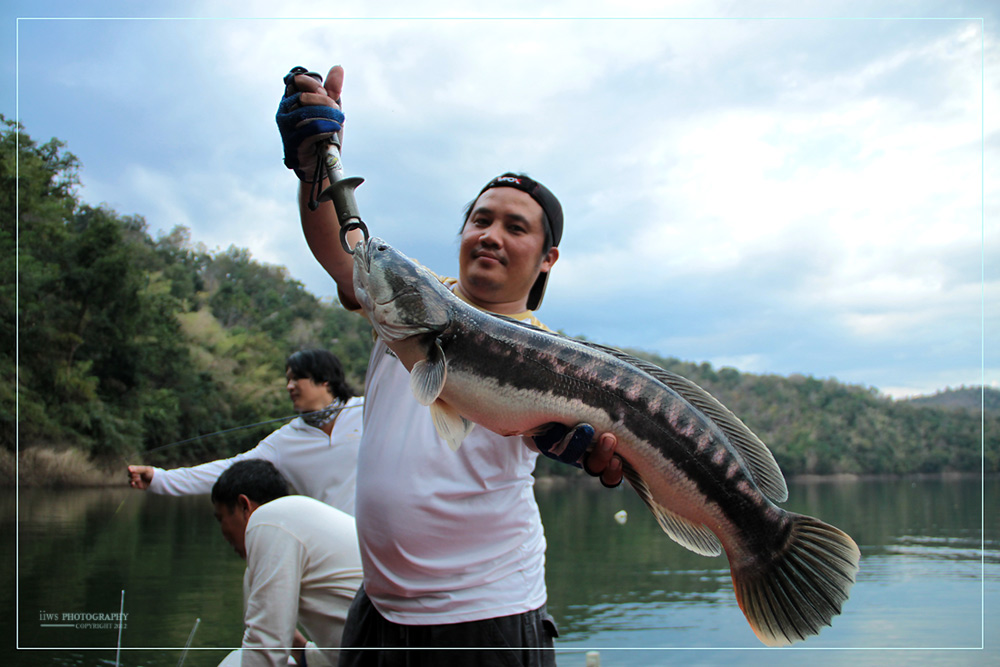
[242,496,362,667]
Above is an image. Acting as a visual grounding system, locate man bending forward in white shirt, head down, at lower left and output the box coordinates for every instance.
[212,459,361,667]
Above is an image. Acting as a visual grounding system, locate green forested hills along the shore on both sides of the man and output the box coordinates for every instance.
[0,120,1000,482]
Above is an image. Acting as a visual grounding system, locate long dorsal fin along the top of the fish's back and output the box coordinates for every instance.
[581,341,788,503]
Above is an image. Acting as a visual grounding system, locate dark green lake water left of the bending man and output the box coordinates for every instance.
[10,489,250,665]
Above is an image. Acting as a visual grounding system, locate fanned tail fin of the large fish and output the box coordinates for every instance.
[732,514,861,646]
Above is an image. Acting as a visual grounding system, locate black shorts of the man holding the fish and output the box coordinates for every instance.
[338,587,558,667]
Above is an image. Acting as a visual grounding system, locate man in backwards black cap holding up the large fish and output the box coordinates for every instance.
[278,67,622,665]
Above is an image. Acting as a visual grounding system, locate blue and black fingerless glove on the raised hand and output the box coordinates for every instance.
[275,67,344,183]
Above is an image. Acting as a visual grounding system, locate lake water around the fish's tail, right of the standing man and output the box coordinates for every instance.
[539,479,1000,664]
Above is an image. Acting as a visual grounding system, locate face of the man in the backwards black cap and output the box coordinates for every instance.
[458,187,559,313]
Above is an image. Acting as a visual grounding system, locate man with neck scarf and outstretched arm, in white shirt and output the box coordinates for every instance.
[128,349,363,516]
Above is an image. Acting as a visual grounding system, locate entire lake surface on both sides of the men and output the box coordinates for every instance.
[0,478,1000,667]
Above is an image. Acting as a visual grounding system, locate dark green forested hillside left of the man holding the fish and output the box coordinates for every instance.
[0,120,371,470]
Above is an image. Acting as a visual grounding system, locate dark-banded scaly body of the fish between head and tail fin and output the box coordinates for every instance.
[437,318,788,559]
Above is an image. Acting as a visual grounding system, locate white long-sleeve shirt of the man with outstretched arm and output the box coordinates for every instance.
[149,397,364,516]
